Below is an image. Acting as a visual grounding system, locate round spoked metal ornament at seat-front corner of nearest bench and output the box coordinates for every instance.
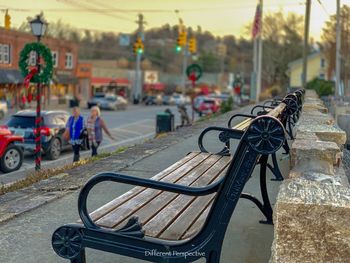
[52,226,83,259]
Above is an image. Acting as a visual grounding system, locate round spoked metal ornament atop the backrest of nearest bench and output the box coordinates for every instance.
[246,116,285,154]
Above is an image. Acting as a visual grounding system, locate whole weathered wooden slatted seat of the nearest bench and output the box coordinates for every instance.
[86,152,231,240]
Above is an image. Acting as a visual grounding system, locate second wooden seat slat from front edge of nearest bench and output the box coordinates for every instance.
[96,153,210,228]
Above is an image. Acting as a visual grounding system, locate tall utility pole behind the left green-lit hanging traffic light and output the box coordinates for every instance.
[134,14,146,104]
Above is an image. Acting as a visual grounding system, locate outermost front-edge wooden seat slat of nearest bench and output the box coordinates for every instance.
[90,152,199,221]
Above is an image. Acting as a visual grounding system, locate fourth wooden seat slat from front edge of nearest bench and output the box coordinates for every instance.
[143,156,230,237]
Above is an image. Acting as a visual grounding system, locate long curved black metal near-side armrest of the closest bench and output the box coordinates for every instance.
[78,172,222,229]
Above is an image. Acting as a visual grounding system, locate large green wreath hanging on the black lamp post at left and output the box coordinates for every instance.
[18,42,53,83]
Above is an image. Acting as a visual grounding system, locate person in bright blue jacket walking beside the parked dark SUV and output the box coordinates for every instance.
[64,107,84,162]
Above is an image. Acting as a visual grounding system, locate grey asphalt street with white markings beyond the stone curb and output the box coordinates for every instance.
[0,105,194,184]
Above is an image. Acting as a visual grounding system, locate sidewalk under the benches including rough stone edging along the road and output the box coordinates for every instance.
[0,108,288,263]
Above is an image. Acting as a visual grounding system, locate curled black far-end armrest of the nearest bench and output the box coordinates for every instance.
[198,126,244,155]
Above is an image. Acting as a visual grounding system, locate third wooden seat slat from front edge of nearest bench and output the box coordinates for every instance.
[110,155,221,231]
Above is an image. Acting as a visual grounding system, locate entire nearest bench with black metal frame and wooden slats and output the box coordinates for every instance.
[52,110,285,263]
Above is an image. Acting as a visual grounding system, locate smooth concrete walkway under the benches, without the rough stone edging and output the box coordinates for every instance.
[0,108,289,263]
